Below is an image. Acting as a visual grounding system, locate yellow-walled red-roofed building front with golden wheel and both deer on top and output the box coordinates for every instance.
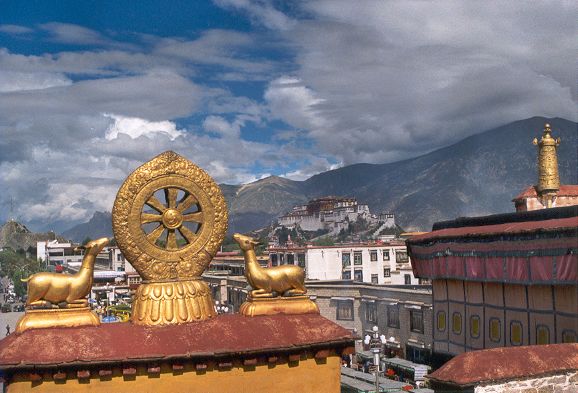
[0,152,354,393]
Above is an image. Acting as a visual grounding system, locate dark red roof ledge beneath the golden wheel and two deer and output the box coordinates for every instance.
[0,314,354,369]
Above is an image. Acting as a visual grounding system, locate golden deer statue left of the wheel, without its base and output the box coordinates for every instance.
[22,238,108,308]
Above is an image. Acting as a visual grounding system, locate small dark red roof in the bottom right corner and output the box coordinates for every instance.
[428,343,578,387]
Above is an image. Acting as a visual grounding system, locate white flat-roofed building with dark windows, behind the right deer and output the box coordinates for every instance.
[268,240,420,285]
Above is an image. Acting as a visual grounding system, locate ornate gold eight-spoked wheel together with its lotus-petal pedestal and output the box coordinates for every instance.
[112,151,228,325]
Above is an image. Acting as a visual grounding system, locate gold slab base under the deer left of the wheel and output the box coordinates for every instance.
[16,307,100,333]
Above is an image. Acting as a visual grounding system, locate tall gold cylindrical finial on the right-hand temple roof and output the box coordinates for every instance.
[533,123,560,207]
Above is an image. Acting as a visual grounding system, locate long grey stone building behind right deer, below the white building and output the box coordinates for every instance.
[203,274,433,363]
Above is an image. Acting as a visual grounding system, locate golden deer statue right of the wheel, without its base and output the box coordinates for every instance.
[233,233,307,298]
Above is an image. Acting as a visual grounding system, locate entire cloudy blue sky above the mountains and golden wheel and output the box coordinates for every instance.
[0,0,578,229]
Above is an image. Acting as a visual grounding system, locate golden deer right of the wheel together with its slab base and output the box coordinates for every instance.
[233,233,319,316]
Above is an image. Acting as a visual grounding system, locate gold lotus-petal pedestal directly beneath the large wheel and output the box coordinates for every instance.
[131,280,216,326]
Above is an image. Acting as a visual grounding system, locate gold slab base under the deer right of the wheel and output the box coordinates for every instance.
[239,296,319,317]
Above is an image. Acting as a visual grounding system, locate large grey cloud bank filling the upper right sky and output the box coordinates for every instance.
[231,0,578,164]
